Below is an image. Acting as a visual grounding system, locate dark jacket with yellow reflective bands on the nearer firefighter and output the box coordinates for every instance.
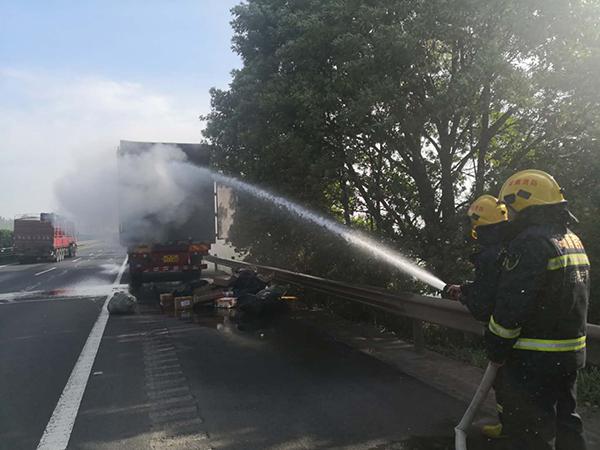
[486,205,590,372]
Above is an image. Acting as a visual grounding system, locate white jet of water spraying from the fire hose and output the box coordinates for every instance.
[198,168,446,291]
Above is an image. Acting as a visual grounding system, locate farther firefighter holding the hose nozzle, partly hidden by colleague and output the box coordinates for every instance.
[446,195,510,439]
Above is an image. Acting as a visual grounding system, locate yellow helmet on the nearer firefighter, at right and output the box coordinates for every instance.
[499,169,565,212]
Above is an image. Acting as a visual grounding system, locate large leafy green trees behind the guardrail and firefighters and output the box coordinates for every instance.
[205,0,600,302]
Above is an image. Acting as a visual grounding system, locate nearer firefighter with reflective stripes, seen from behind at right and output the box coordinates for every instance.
[486,170,590,450]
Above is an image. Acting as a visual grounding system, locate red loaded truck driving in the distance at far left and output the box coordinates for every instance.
[13,213,77,264]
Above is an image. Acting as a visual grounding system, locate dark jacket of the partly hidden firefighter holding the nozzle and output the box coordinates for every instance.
[460,222,511,323]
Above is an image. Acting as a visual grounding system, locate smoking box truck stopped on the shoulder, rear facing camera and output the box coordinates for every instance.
[117,140,215,287]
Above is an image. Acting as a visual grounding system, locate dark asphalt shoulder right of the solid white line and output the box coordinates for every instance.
[69,298,474,450]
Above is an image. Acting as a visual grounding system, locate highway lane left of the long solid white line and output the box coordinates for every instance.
[0,242,124,449]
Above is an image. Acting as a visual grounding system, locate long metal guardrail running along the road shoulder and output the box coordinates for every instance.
[203,255,600,365]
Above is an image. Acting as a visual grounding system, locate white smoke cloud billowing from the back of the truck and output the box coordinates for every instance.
[55,144,212,242]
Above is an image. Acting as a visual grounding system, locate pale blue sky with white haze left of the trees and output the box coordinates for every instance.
[0,0,240,217]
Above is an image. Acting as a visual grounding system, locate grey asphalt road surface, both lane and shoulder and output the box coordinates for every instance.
[0,243,486,450]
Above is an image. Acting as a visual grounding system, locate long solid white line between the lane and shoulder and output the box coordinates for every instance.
[37,258,127,450]
